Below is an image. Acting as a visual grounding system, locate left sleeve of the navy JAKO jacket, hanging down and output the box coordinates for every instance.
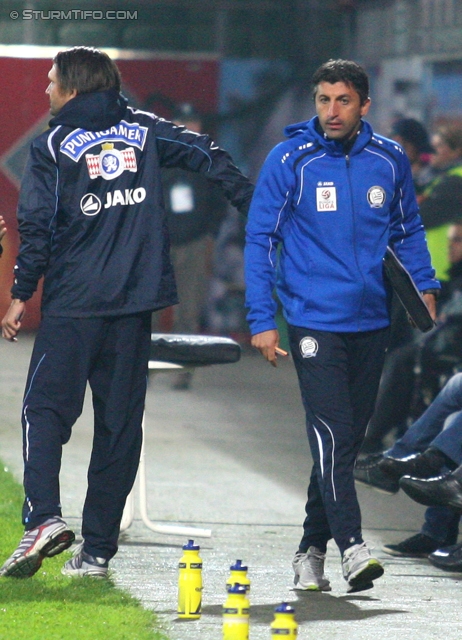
[11,133,58,300]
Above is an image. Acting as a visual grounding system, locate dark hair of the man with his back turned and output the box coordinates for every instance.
[53,47,121,93]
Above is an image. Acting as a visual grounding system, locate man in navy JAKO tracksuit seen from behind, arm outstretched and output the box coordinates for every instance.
[0,47,253,577]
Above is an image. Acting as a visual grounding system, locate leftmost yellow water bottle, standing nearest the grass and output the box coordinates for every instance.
[178,540,202,620]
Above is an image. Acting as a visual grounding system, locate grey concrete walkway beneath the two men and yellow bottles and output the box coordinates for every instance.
[0,335,462,640]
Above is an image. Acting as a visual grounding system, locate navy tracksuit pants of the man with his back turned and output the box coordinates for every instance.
[22,312,151,559]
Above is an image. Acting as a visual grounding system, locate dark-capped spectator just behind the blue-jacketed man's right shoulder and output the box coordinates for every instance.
[390,118,434,196]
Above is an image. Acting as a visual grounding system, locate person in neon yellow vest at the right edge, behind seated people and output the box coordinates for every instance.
[419,124,462,280]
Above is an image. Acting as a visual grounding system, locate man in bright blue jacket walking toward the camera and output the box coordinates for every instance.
[245,60,439,591]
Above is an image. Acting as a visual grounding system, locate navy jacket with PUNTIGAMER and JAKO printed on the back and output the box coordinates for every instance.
[12,89,253,317]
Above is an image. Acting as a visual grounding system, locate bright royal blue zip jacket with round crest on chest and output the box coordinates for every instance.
[245,117,440,335]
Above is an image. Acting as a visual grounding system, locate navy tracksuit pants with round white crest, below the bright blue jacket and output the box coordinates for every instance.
[289,326,389,554]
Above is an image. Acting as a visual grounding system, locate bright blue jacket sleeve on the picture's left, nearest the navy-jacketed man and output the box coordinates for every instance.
[244,145,293,335]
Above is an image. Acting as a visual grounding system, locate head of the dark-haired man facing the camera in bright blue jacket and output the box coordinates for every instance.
[312,60,370,141]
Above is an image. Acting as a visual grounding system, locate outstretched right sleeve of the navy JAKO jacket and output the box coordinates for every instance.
[156,120,254,215]
